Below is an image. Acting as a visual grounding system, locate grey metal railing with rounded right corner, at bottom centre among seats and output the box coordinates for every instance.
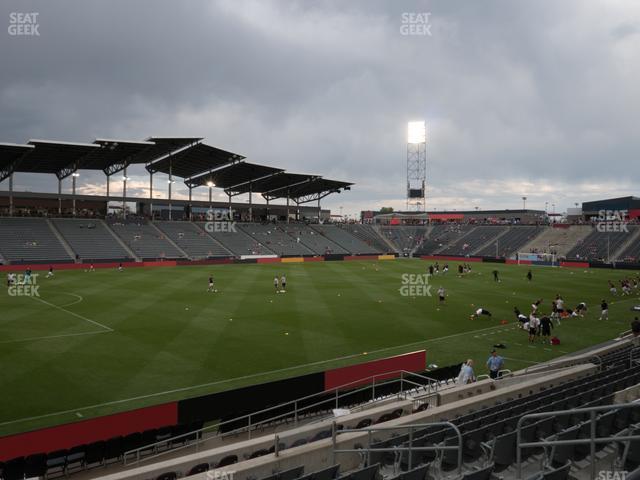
[332,422,462,474]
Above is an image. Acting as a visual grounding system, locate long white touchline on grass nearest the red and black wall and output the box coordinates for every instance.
[0,325,516,426]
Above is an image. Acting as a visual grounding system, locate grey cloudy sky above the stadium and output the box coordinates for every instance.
[0,0,640,214]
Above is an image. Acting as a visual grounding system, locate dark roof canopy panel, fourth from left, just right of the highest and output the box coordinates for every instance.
[147,144,245,178]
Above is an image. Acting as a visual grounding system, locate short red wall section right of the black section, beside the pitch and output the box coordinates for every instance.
[324,350,427,390]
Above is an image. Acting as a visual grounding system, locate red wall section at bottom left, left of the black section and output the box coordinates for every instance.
[0,402,178,461]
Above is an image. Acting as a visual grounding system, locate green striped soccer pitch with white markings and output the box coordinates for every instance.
[0,260,640,434]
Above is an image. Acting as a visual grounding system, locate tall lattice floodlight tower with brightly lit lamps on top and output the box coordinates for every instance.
[407,120,427,212]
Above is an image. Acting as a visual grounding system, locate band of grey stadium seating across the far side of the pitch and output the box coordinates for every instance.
[0,217,640,263]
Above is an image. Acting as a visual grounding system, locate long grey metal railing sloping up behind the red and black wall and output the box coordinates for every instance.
[123,370,440,465]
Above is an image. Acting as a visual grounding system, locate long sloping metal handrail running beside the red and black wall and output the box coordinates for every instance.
[123,370,440,465]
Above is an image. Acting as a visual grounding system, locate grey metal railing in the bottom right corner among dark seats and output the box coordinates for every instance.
[516,403,640,480]
